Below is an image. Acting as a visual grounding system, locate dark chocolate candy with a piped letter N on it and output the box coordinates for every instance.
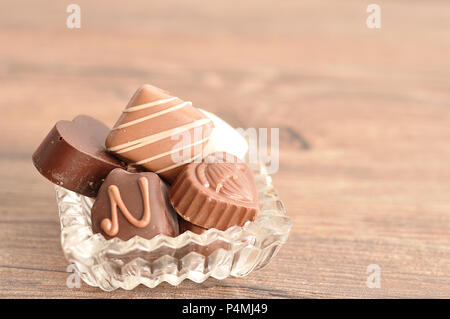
[91,169,179,240]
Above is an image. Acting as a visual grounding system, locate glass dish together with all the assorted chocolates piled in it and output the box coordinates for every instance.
[32,85,290,290]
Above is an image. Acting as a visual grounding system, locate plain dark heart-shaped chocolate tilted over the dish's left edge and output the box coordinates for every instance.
[33,115,123,197]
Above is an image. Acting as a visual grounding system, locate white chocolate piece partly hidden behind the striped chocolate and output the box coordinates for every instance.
[199,109,248,160]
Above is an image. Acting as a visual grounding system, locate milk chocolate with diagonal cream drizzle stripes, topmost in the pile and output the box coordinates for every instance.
[106,85,213,183]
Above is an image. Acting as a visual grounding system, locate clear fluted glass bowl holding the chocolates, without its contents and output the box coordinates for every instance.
[55,165,291,291]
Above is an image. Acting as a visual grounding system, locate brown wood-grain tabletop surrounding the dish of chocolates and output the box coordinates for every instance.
[0,0,450,298]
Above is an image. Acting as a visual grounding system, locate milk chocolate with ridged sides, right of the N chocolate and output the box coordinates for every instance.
[169,153,258,230]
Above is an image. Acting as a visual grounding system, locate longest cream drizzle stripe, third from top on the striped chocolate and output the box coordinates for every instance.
[108,119,211,154]
